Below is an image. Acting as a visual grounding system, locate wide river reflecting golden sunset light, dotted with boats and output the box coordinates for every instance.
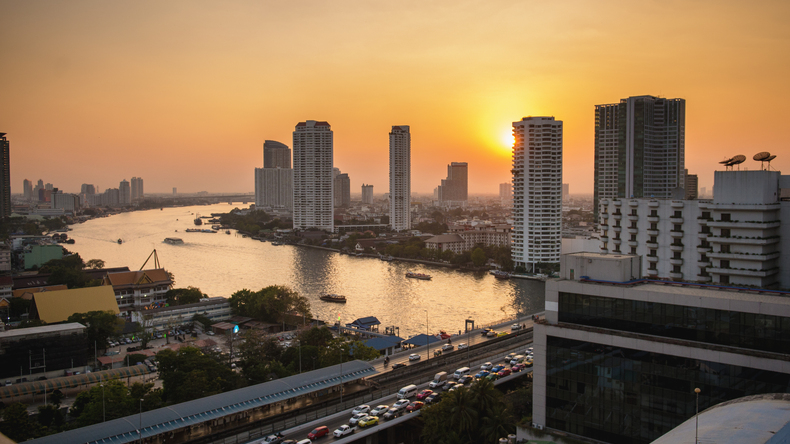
[67,203,544,337]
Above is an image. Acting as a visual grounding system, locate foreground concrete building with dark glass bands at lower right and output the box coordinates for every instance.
[533,253,790,444]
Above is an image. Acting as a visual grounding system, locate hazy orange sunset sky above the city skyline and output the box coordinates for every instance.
[0,0,790,194]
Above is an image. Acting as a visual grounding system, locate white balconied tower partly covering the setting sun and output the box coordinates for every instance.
[511,117,562,272]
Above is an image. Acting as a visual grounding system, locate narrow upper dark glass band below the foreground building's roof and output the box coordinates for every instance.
[559,293,790,353]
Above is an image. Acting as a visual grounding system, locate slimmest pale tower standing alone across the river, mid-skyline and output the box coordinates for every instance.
[392,125,411,231]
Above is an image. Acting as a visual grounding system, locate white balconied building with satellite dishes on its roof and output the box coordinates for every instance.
[600,171,790,288]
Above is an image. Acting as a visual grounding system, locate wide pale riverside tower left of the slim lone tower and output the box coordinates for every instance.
[293,120,335,231]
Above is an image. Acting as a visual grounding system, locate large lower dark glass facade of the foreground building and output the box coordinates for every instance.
[546,336,790,444]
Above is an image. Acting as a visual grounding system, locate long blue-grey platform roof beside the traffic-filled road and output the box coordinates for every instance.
[26,361,376,444]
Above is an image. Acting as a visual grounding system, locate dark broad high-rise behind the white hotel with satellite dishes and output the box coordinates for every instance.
[593,96,686,220]
